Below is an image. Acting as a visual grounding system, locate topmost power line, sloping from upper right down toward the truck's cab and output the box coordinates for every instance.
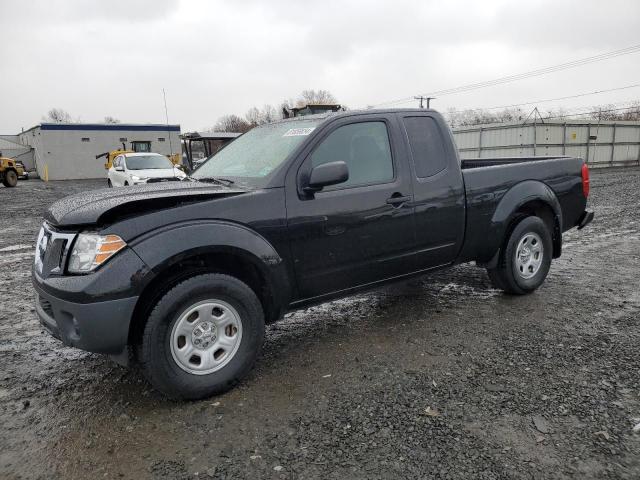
[375,44,640,107]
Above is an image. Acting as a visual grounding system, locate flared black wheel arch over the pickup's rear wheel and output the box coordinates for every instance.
[482,180,562,259]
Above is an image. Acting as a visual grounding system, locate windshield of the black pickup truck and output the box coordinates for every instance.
[191,119,321,180]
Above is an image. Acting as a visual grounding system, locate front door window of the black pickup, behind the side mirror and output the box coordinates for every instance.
[311,122,393,190]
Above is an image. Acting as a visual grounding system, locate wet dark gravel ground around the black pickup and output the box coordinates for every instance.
[0,168,640,479]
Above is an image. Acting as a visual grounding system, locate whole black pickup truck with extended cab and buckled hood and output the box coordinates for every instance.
[33,110,593,399]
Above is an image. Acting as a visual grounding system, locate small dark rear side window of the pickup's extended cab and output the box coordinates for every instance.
[403,117,447,178]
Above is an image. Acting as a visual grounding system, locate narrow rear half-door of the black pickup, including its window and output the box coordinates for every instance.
[399,113,465,269]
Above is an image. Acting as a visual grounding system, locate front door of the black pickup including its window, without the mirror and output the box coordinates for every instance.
[286,115,415,298]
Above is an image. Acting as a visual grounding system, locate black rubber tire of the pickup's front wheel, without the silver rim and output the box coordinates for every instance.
[138,274,264,400]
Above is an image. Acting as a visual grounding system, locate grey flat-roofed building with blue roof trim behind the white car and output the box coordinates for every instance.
[15,123,182,180]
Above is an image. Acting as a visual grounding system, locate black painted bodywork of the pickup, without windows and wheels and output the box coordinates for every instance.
[33,110,586,352]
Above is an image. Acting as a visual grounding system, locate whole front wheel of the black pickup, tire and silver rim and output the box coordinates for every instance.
[140,274,264,400]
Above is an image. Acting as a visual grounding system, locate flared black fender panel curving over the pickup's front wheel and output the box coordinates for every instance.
[130,220,291,316]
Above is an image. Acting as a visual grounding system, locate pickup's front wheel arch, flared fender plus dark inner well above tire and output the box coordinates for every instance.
[129,221,291,344]
